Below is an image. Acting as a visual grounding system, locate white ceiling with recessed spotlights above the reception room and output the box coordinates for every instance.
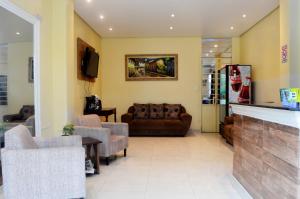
[75,0,279,37]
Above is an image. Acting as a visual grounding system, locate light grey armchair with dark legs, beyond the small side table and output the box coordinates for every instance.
[74,115,128,165]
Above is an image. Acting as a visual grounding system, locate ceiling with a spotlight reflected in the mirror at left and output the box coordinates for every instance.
[0,7,33,44]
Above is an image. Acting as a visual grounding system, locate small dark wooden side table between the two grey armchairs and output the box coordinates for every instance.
[82,137,102,174]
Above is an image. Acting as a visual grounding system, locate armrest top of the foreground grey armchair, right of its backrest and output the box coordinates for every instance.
[33,135,82,148]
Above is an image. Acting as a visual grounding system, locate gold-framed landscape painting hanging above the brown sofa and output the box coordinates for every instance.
[125,54,178,81]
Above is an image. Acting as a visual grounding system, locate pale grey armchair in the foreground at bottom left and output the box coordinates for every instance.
[1,125,85,199]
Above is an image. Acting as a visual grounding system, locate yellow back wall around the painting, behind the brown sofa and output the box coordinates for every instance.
[100,38,201,129]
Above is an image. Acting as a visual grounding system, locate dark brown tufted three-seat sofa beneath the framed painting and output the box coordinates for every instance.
[122,104,192,137]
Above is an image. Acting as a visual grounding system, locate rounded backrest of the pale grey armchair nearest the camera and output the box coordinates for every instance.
[5,125,38,150]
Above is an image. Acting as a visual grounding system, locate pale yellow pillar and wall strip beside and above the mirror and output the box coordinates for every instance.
[11,0,74,136]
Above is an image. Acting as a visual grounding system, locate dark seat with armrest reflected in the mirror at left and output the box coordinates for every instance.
[3,105,34,123]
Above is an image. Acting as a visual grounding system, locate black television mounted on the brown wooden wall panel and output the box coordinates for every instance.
[82,48,99,77]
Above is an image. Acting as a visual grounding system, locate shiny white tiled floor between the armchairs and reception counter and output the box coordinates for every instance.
[0,131,251,199]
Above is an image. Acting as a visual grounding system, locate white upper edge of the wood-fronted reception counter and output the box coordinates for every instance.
[230,103,300,129]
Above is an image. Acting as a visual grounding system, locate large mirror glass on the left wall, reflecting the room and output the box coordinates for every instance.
[0,7,35,146]
